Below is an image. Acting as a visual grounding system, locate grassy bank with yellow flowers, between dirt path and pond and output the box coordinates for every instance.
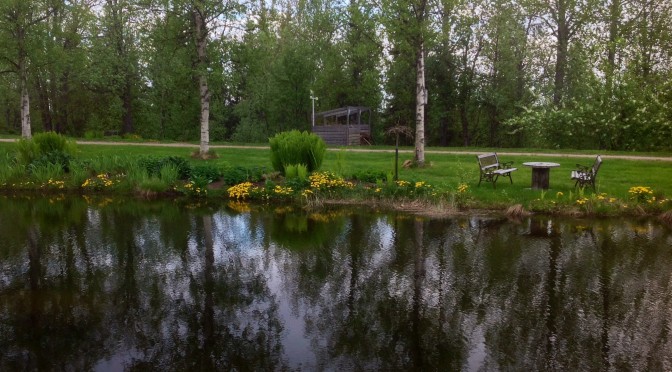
[0,138,672,215]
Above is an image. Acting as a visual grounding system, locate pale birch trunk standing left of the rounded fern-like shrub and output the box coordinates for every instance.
[193,2,210,156]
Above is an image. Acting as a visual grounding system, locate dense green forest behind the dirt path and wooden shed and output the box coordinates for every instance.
[0,0,672,151]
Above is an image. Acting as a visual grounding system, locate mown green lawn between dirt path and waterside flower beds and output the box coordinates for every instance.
[0,143,672,215]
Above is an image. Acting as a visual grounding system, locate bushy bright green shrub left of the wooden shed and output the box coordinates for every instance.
[269,130,327,172]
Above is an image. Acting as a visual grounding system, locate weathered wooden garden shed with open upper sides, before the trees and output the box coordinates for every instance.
[313,106,371,146]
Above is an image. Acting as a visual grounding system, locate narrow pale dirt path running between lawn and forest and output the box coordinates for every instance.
[0,138,672,162]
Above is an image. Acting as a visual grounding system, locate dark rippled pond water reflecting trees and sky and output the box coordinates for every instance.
[0,196,672,371]
